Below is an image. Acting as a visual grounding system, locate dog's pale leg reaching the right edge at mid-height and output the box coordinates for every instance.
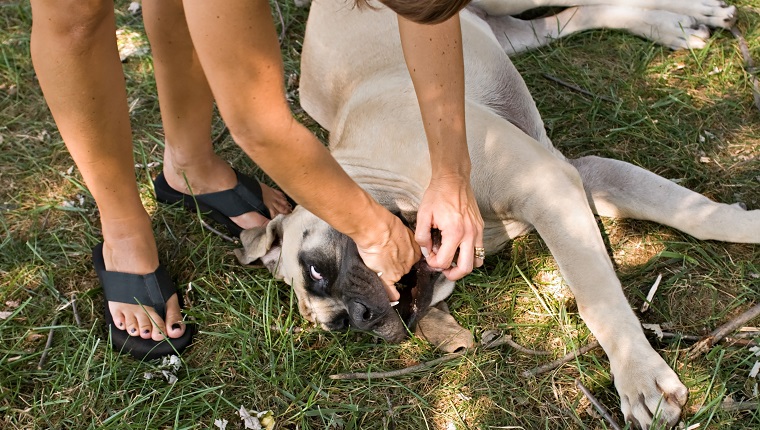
[568,156,760,243]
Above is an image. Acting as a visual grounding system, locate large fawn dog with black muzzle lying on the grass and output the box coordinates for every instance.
[236,0,760,428]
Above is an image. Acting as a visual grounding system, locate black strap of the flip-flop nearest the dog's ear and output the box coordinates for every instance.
[195,170,271,218]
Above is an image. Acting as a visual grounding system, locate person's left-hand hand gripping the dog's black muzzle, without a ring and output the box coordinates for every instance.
[356,211,421,302]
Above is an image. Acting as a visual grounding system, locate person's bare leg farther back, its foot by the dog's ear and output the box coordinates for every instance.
[143,0,290,228]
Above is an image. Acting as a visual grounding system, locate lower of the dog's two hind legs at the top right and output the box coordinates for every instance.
[484,6,710,54]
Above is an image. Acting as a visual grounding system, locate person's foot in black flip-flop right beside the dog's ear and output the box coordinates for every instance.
[164,151,293,229]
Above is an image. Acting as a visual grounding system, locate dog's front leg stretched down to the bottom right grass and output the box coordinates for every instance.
[524,161,688,428]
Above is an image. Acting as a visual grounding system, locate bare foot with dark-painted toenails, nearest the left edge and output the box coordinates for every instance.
[102,214,185,342]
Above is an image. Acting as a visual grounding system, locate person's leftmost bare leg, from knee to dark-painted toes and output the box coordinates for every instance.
[31,0,185,340]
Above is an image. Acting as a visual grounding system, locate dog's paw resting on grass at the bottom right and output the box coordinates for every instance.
[613,351,689,429]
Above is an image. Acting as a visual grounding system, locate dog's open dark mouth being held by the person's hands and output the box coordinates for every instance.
[393,258,441,329]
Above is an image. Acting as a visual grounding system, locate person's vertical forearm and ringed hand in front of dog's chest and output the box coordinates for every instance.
[398,15,483,280]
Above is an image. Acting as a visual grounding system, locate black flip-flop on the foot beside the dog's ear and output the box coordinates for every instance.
[153,170,286,237]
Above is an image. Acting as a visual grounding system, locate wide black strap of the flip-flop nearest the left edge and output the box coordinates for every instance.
[99,266,177,318]
